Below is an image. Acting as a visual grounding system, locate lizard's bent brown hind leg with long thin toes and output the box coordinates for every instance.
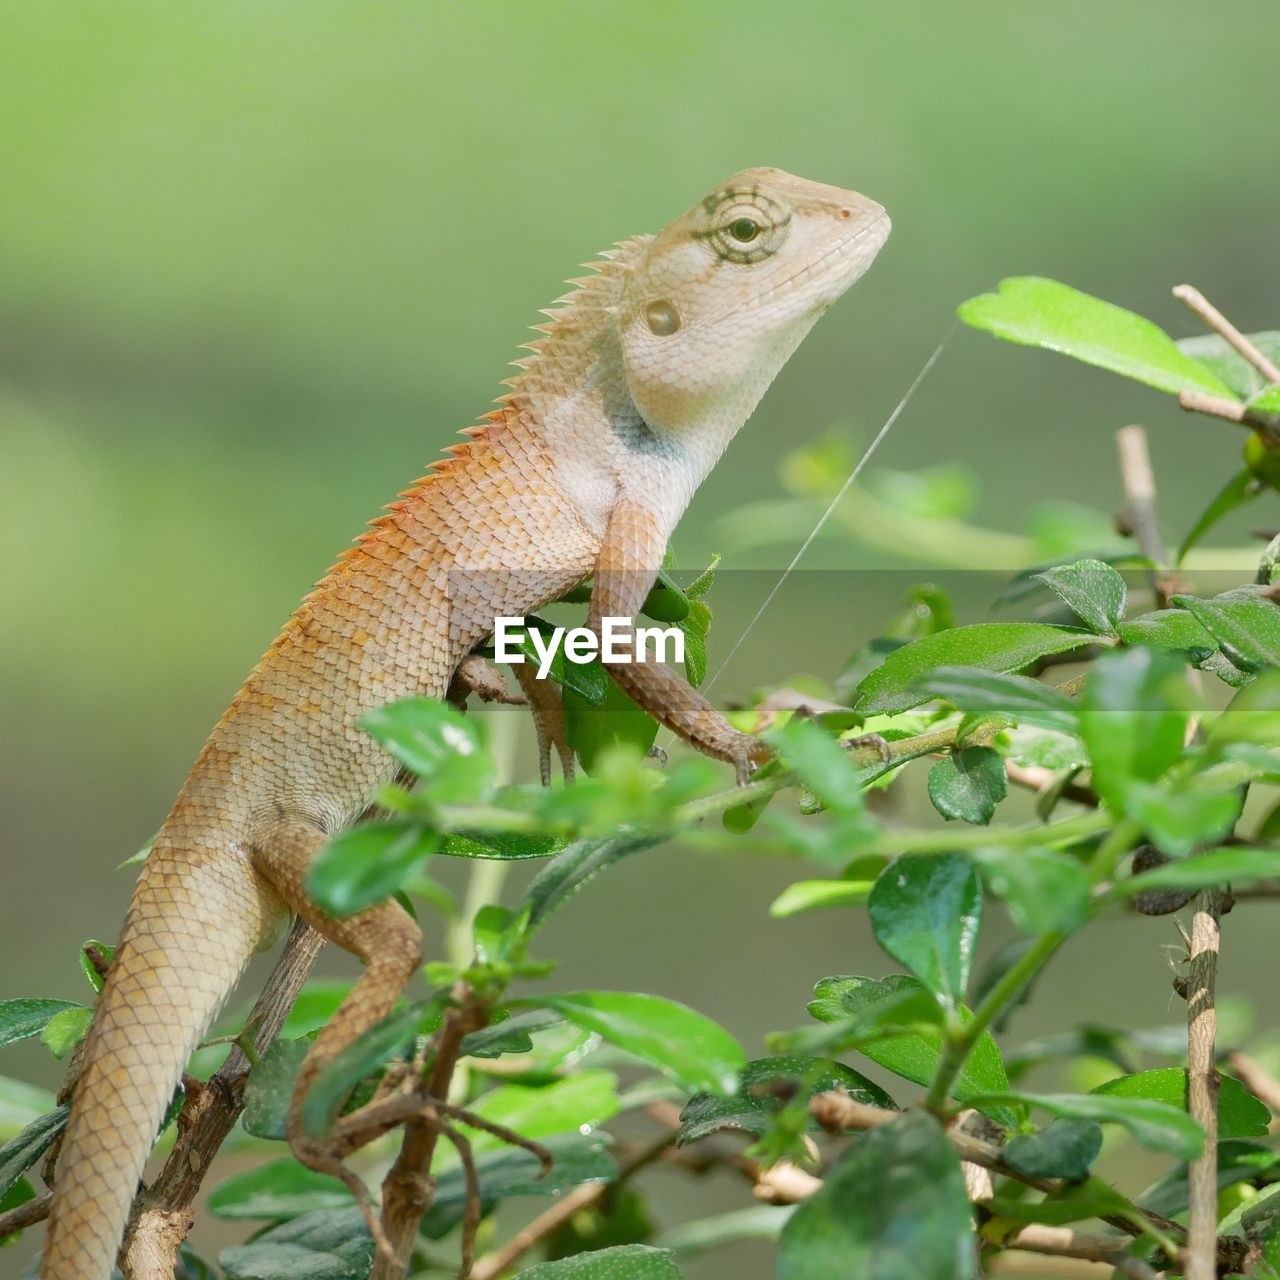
[253,820,422,1187]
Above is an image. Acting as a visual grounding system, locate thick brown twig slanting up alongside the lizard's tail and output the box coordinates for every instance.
[120,920,324,1280]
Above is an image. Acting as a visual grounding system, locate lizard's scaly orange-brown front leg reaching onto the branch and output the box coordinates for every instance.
[588,498,771,782]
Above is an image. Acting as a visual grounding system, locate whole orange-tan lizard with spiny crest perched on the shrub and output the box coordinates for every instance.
[38,168,890,1280]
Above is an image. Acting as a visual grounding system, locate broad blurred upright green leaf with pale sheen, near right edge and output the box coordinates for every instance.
[1080,649,1187,812]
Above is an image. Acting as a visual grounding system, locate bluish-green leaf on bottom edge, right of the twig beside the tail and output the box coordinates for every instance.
[218,1208,375,1280]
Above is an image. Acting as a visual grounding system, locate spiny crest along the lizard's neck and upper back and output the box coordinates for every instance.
[306,236,653,581]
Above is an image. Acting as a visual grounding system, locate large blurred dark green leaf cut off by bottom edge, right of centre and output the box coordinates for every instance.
[778,1111,978,1280]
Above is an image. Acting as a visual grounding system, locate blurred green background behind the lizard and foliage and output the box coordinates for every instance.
[0,0,1280,1276]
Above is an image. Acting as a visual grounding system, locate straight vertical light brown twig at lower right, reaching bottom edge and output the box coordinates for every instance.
[1183,890,1222,1280]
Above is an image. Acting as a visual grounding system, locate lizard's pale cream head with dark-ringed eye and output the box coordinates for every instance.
[620,169,890,447]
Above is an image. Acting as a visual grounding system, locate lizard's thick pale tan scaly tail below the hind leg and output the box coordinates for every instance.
[40,835,283,1280]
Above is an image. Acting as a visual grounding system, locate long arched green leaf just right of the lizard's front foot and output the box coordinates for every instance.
[854,622,1094,716]
